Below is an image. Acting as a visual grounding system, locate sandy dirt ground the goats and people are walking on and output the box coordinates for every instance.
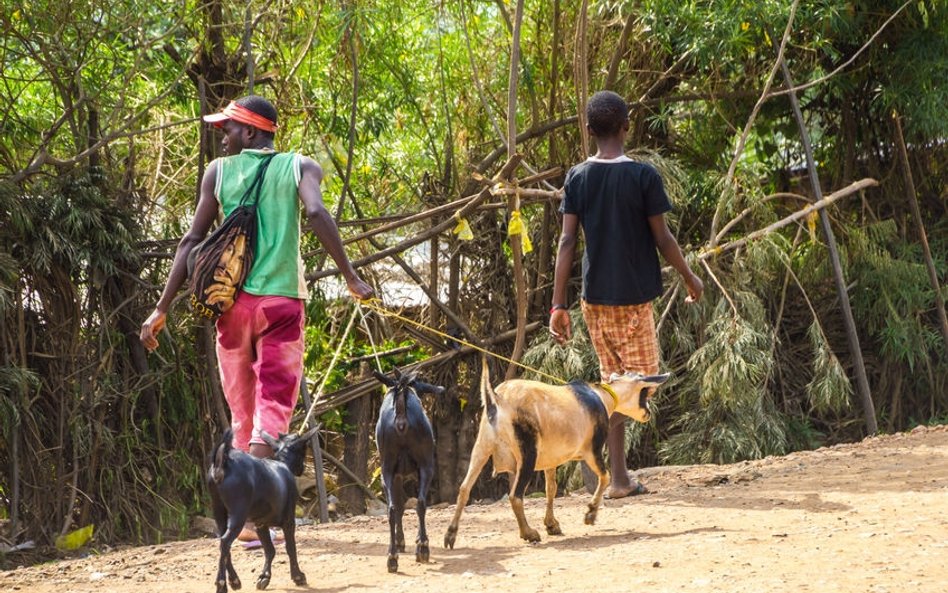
[0,426,948,593]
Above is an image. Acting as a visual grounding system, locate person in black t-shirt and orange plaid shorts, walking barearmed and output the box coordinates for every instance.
[550,91,704,498]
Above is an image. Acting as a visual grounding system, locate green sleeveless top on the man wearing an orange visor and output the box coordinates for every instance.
[214,149,308,299]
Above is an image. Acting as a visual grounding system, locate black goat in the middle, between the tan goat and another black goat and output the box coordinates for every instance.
[375,369,444,572]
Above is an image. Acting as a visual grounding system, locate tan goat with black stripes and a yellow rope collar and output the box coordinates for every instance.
[444,364,669,548]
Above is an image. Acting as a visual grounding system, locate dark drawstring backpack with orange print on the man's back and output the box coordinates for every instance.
[188,155,274,319]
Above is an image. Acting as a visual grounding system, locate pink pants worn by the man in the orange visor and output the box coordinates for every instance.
[217,291,304,451]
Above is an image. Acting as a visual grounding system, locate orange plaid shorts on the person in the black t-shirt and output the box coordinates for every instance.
[582,301,658,381]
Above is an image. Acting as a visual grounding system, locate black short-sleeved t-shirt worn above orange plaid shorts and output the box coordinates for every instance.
[560,156,671,305]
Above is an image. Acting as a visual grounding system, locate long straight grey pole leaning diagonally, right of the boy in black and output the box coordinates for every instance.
[779,56,879,435]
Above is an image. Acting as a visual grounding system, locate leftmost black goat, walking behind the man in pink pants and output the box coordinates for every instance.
[207,428,317,593]
